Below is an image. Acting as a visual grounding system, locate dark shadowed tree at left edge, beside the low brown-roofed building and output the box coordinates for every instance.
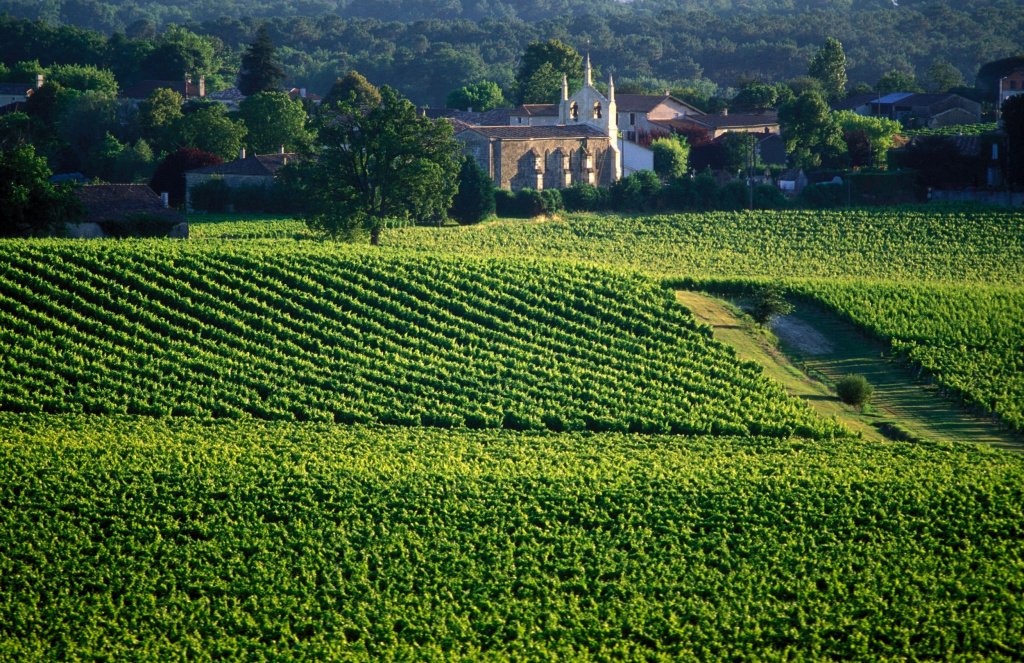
[0,144,81,235]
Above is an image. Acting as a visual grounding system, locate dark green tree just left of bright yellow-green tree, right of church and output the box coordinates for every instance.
[778,92,845,168]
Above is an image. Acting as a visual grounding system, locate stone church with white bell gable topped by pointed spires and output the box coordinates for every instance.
[456,55,623,191]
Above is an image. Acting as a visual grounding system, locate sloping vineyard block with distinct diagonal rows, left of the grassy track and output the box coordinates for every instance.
[0,241,842,438]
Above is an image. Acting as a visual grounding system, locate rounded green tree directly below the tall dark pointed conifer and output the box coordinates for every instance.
[239,92,312,154]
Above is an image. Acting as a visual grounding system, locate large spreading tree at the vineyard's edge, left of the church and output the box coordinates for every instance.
[299,86,459,245]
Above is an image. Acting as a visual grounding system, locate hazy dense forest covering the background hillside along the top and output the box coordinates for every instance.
[0,0,1024,106]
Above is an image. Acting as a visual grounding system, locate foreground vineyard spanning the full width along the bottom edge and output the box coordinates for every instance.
[0,415,1024,661]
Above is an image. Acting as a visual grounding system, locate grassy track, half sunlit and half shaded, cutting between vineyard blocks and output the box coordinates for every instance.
[676,291,1024,450]
